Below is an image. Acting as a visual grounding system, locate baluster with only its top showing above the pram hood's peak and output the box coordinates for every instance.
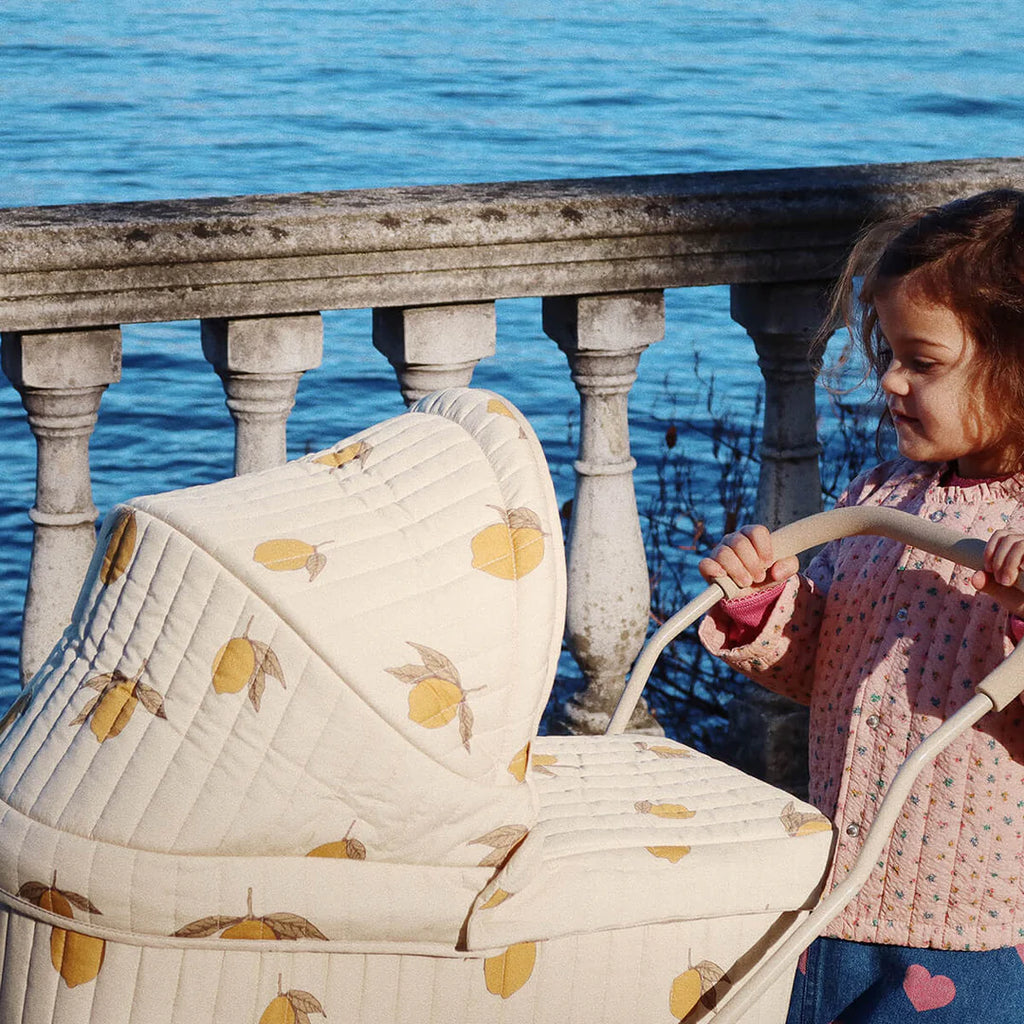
[374,302,496,406]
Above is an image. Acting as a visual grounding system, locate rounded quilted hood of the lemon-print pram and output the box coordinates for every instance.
[0,389,565,948]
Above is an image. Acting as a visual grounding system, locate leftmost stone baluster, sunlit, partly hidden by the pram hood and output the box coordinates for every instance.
[3,327,121,682]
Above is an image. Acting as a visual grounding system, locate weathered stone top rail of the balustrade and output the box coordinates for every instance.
[0,159,1024,331]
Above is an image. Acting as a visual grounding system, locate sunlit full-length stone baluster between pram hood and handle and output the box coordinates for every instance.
[543,291,665,734]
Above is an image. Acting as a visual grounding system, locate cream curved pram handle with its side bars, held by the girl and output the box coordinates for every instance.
[606,506,1024,1024]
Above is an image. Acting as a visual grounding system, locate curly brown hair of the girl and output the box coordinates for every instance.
[818,188,1024,464]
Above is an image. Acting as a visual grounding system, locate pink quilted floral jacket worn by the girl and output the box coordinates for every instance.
[700,459,1024,949]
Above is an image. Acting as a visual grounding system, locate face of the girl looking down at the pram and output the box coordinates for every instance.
[874,284,1016,477]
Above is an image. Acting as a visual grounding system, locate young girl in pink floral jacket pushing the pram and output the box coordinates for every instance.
[700,189,1024,1024]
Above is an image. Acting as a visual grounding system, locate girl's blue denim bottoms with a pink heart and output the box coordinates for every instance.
[786,938,1024,1024]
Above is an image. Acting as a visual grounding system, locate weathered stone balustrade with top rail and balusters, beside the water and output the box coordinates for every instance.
[0,159,1024,757]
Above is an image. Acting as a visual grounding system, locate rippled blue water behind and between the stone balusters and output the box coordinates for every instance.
[0,0,1024,702]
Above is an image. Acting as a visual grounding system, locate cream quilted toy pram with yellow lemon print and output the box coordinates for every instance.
[0,389,1009,1024]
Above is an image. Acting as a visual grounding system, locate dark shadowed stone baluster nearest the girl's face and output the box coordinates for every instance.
[729,282,827,796]
